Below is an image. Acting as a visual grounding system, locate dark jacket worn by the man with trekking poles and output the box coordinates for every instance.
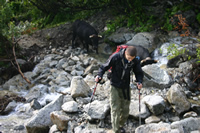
[98,49,144,89]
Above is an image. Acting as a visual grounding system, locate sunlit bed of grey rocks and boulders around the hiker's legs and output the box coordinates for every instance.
[0,30,200,133]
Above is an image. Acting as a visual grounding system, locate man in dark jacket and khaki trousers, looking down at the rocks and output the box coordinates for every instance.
[95,46,144,133]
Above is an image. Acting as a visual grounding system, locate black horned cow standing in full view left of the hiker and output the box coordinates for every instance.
[72,20,101,54]
